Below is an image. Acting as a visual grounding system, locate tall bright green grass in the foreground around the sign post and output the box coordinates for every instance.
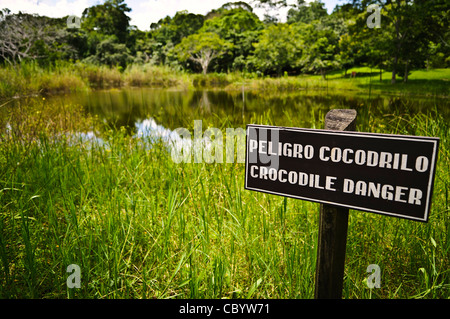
[0,95,450,299]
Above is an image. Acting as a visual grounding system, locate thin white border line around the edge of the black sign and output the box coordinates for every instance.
[244,124,440,223]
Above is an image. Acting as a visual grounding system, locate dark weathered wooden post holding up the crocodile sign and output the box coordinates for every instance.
[315,110,357,299]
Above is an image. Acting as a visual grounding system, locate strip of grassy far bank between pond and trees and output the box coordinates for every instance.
[0,62,450,100]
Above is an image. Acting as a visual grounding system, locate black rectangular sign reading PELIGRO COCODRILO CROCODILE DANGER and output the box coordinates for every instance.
[245,125,439,222]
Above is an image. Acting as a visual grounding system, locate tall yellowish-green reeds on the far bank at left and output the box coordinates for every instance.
[0,61,189,98]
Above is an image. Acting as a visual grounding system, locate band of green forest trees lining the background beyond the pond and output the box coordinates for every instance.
[0,0,450,83]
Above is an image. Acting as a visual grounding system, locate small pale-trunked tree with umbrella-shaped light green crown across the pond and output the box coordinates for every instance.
[174,32,233,74]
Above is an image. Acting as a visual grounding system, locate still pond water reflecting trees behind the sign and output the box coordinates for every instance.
[48,88,450,135]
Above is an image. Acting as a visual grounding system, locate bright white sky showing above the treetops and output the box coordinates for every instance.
[0,0,343,31]
